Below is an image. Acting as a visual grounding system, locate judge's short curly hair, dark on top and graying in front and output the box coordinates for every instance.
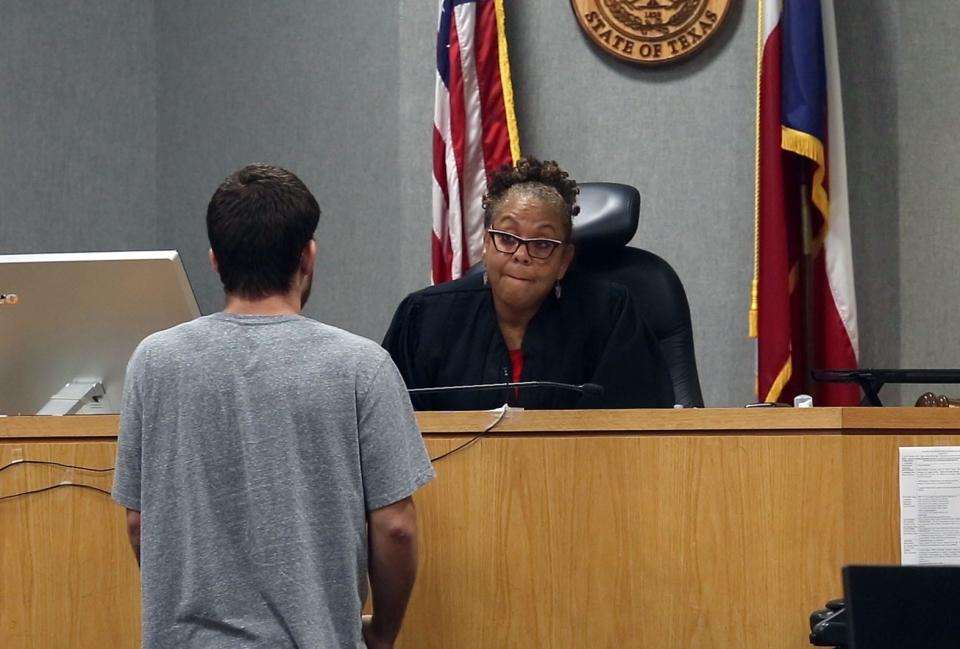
[483,157,580,237]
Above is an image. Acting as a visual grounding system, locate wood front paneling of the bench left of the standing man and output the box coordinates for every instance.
[0,438,140,649]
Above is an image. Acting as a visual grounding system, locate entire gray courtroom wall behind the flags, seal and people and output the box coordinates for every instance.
[0,0,960,405]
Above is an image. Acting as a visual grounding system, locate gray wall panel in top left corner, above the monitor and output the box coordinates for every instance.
[0,0,156,253]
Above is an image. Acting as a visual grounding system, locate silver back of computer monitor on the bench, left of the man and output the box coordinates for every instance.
[0,250,200,415]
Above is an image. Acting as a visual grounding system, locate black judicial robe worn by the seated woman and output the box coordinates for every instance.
[383,274,673,410]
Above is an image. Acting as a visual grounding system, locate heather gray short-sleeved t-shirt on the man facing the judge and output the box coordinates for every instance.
[113,313,433,649]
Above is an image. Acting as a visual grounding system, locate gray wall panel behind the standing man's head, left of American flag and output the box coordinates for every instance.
[157,0,403,338]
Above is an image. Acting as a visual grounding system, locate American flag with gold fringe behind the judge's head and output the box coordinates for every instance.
[432,0,520,284]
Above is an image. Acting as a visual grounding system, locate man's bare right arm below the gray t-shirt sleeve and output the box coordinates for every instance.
[363,497,417,649]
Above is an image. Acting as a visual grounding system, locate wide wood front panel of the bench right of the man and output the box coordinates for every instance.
[401,435,843,648]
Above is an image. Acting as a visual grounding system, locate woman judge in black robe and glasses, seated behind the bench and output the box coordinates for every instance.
[383,158,673,410]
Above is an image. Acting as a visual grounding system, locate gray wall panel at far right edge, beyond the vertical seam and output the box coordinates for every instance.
[898,0,960,401]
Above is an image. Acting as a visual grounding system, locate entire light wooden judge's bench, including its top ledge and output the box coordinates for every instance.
[0,408,960,649]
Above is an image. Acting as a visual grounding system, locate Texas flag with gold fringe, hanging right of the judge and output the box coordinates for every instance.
[751,0,859,406]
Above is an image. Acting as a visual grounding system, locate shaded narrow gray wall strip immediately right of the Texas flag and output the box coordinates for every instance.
[835,2,901,404]
